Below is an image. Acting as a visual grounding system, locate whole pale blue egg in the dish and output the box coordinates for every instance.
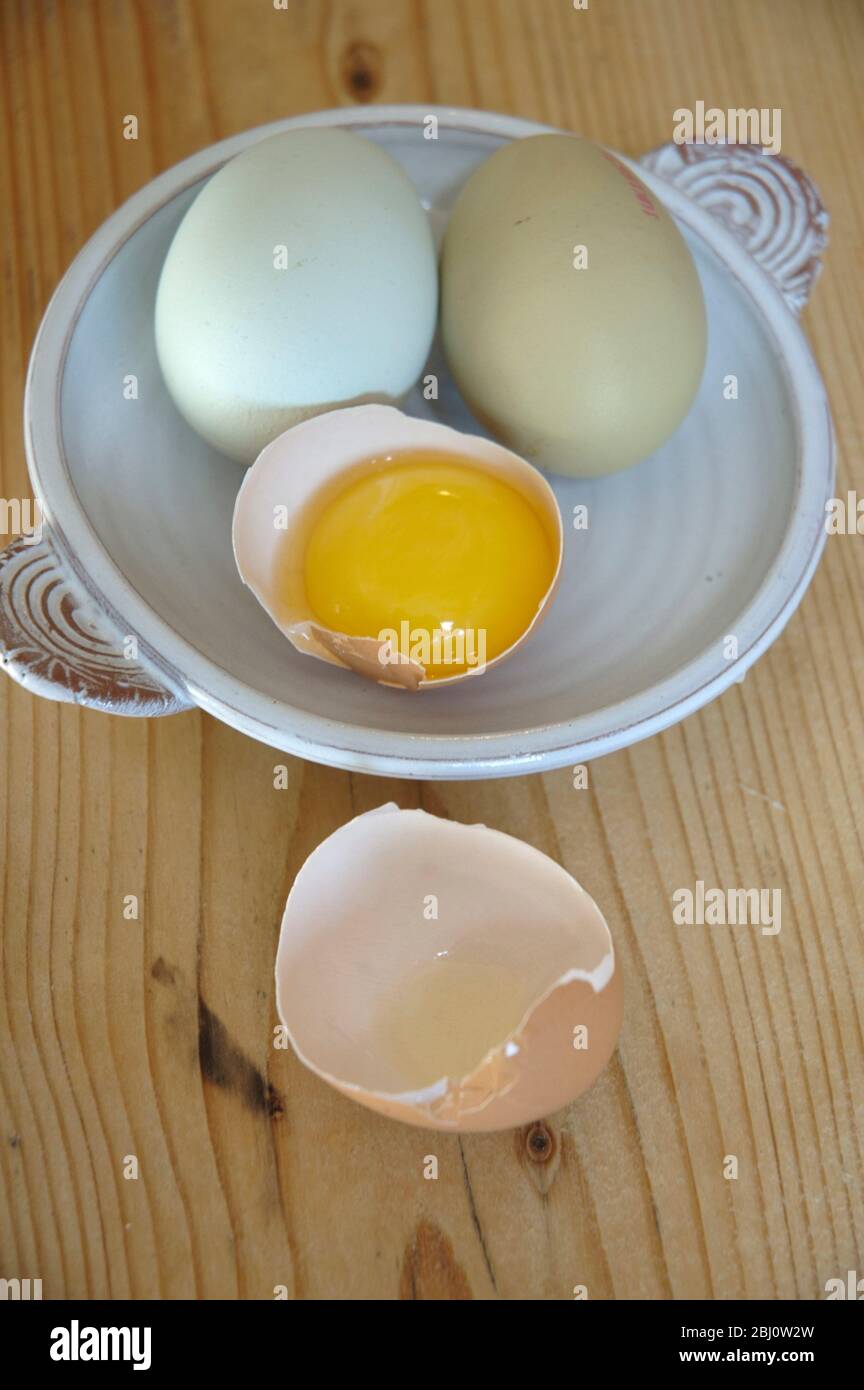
[156,128,438,464]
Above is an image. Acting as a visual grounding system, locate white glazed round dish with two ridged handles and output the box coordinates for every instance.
[0,107,833,778]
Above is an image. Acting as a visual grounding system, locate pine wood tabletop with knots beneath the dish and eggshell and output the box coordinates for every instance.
[0,0,864,1298]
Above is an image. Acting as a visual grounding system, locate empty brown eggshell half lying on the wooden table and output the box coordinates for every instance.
[276,805,622,1131]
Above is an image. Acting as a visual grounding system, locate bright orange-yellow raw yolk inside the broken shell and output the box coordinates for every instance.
[304,452,556,680]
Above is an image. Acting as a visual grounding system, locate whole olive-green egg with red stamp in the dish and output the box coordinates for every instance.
[442,135,706,477]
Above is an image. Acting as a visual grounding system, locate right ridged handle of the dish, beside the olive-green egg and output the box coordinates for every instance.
[639,142,828,314]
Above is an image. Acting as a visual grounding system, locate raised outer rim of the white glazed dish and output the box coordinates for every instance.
[24,104,835,780]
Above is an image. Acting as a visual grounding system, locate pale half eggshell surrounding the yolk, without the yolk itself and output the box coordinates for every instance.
[232,404,564,689]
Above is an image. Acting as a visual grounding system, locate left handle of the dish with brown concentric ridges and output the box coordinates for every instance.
[0,524,192,716]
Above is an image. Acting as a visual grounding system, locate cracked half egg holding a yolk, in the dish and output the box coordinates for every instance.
[232,406,564,691]
